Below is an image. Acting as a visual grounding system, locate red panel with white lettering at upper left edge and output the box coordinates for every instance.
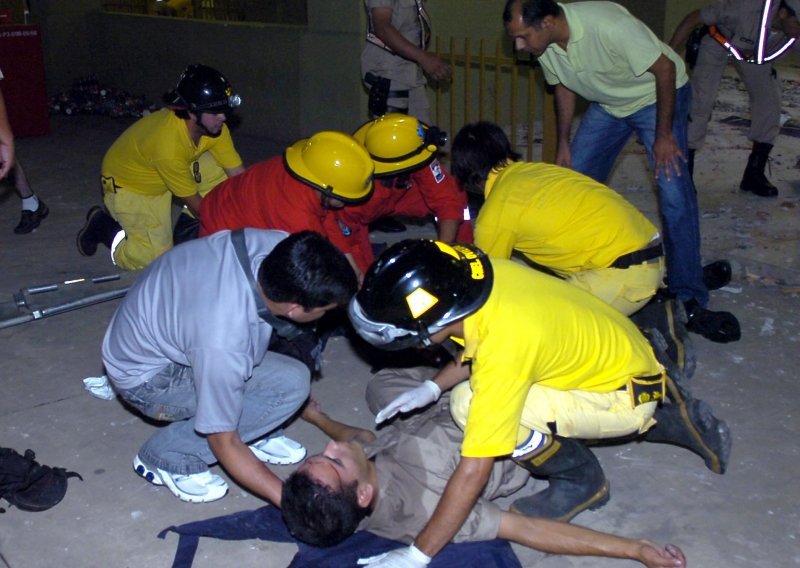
[0,25,50,137]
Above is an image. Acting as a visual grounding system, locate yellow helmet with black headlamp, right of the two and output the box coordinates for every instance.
[353,113,447,177]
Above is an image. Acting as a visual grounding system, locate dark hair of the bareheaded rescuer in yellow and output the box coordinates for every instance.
[450,121,521,194]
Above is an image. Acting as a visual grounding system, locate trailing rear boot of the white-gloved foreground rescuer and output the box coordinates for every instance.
[644,398,733,474]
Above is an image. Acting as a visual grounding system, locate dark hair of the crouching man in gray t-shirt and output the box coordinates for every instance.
[258,231,358,309]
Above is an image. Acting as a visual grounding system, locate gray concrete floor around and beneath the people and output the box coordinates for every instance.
[0,58,800,568]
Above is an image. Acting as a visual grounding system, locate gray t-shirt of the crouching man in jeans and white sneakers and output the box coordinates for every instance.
[102,229,287,434]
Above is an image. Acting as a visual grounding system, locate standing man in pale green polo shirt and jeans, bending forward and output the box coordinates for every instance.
[503,0,741,343]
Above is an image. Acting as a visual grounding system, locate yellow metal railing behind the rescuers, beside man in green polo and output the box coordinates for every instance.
[432,37,556,162]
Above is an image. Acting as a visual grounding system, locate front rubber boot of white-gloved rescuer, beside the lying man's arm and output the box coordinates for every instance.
[511,436,609,521]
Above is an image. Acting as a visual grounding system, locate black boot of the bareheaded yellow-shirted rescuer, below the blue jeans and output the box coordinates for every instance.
[630,294,697,379]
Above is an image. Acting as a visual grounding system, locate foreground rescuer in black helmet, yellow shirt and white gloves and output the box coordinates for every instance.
[316,239,730,566]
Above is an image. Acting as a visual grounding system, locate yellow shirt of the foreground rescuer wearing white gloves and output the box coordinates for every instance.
[461,259,663,457]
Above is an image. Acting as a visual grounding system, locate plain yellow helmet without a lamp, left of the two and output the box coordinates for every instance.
[284,131,373,203]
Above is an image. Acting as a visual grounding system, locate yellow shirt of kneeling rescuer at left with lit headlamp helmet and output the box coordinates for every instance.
[102,109,242,197]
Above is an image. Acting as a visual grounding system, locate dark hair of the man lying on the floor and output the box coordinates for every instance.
[281,471,370,546]
